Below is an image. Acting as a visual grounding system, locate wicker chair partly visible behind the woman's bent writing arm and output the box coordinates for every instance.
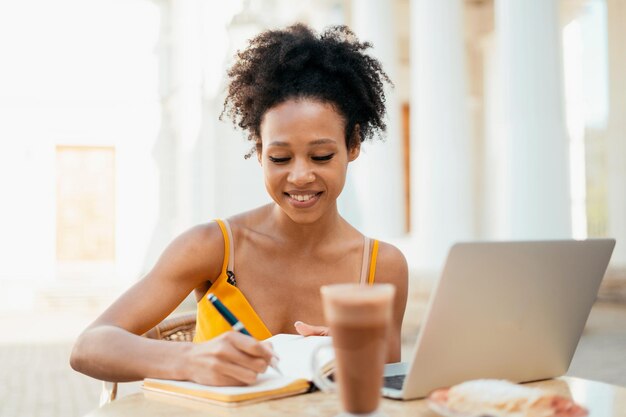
[100,313,196,407]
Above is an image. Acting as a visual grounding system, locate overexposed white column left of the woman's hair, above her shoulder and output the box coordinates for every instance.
[142,0,206,272]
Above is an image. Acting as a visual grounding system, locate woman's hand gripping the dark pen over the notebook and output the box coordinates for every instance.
[183,331,274,386]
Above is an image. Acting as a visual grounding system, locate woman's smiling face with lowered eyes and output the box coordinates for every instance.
[259,99,360,223]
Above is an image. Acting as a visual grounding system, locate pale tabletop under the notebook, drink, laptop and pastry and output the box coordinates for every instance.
[86,377,626,417]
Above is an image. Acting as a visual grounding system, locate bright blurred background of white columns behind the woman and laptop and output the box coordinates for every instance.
[0,0,626,416]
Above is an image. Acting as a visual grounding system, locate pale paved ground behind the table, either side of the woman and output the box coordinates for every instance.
[0,300,626,417]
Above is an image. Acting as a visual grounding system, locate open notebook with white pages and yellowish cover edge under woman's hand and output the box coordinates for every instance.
[143,334,333,406]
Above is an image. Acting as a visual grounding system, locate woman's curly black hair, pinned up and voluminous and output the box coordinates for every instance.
[220,23,393,157]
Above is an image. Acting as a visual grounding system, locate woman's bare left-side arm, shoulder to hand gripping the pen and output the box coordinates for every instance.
[70,223,272,385]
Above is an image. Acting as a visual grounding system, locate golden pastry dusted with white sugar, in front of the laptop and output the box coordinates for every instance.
[428,379,588,417]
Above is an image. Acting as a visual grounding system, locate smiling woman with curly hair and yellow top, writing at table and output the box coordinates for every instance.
[71,24,408,385]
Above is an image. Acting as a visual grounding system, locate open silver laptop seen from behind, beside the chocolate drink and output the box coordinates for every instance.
[383,239,615,400]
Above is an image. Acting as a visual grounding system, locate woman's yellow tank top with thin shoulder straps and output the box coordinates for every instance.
[193,220,378,342]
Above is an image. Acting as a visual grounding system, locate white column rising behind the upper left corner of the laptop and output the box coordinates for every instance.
[409,0,474,270]
